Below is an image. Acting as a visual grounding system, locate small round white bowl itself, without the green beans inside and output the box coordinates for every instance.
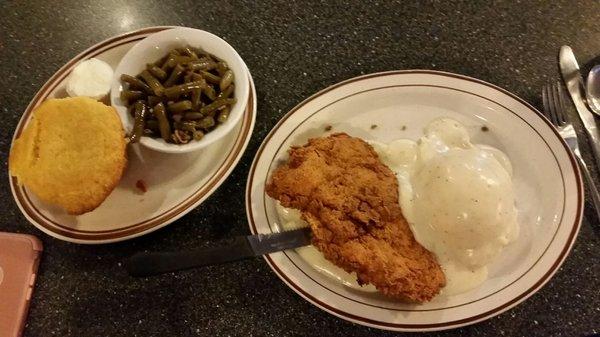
[110,27,250,153]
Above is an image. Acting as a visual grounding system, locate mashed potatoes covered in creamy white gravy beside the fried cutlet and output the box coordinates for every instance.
[372,118,519,295]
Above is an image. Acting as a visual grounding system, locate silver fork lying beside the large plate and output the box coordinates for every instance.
[542,82,600,219]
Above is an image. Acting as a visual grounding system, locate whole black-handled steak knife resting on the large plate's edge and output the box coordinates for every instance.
[125,227,311,277]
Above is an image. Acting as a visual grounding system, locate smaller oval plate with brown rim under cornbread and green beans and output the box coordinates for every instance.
[10,27,256,244]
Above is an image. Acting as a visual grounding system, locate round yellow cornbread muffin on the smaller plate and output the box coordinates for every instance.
[9,97,127,215]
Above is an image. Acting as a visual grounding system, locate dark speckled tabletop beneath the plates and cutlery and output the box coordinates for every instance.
[0,0,600,336]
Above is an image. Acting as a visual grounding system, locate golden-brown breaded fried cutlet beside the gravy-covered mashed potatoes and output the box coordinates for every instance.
[266,133,446,302]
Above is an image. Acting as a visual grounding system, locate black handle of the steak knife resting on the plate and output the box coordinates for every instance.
[125,236,254,277]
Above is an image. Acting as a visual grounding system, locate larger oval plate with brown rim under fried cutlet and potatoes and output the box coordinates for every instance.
[246,71,583,331]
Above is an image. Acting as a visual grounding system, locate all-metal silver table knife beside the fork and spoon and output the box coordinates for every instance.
[558,46,600,168]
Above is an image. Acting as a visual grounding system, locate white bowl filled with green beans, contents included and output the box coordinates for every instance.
[110,27,250,153]
